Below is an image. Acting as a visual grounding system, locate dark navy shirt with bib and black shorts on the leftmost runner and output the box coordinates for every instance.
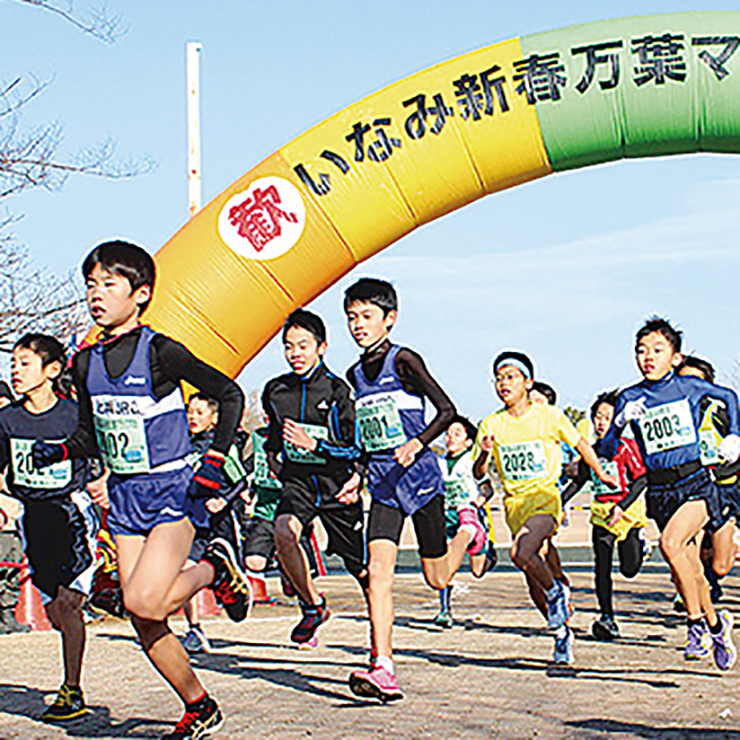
[0,399,99,603]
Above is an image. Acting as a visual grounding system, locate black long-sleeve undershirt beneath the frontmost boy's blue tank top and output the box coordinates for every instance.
[66,327,244,457]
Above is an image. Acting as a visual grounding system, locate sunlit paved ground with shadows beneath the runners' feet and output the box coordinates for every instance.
[0,548,740,740]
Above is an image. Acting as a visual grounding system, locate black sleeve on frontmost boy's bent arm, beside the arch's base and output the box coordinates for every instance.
[153,334,244,455]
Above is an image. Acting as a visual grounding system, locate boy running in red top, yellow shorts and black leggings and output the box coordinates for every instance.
[563,391,647,640]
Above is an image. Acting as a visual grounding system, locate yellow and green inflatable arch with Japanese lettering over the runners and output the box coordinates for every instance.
[147,12,740,377]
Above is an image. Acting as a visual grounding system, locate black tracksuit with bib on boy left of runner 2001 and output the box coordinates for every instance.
[262,362,365,578]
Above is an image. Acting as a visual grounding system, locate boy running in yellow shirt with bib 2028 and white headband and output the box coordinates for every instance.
[473,351,617,664]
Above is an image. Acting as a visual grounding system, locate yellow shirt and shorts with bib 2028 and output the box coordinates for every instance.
[473,404,580,534]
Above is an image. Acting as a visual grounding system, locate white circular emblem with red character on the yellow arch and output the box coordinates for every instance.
[218,177,306,260]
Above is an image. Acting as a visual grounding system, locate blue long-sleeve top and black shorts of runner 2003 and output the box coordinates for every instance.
[601,372,740,531]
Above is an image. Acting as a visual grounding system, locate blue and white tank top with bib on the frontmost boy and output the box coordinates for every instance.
[87,326,192,475]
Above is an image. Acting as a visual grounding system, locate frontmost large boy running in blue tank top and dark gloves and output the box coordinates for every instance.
[33,241,249,740]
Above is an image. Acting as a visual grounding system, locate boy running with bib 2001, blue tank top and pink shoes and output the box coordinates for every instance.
[344,278,488,701]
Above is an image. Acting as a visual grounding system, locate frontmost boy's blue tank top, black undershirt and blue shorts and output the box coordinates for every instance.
[65,326,244,536]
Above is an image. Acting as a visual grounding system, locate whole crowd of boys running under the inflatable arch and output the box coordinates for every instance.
[0,241,740,738]
